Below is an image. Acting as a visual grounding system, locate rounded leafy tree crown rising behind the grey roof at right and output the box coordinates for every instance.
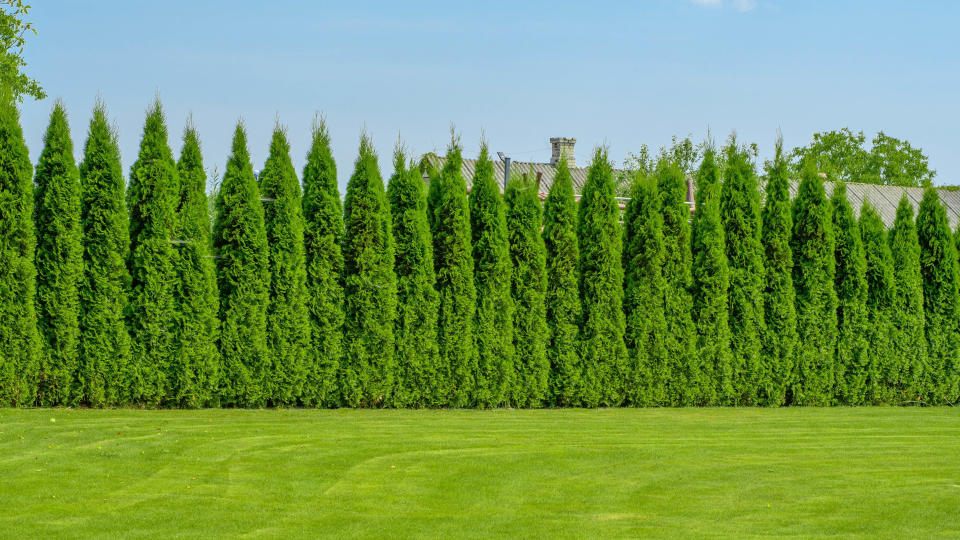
[793,128,937,186]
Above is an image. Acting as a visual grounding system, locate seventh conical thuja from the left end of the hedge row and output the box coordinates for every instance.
[259,127,310,405]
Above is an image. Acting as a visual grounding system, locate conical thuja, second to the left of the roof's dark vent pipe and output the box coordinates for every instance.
[427,138,477,407]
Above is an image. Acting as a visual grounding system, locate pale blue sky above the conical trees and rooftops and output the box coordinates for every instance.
[15,0,960,189]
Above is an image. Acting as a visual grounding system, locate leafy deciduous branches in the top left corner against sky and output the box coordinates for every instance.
[0,0,47,103]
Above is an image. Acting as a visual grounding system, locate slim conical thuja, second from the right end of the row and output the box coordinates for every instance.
[887,194,927,402]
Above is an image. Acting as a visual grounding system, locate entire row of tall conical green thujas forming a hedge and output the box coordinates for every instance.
[0,100,960,408]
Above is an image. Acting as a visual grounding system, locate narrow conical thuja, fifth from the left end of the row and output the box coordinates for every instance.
[168,126,220,407]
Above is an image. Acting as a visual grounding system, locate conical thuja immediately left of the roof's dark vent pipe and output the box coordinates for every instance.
[470,142,520,407]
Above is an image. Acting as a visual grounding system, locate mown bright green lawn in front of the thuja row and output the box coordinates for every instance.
[0,408,960,538]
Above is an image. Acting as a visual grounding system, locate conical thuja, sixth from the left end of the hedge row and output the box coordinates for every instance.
[213,124,270,407]
